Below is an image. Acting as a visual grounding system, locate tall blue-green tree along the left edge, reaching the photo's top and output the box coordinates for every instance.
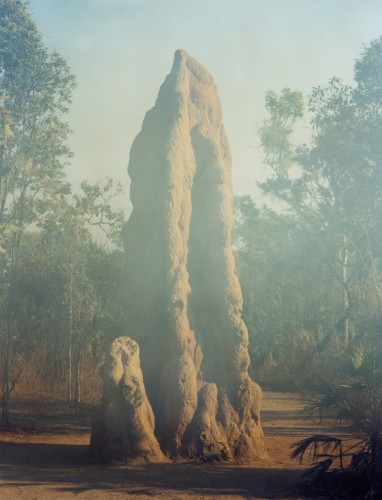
[0,0,74,424]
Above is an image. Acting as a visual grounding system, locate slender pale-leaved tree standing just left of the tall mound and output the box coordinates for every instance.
[38,179,125,408]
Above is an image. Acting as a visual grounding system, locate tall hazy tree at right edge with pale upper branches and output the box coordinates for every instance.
[260,39,382,347]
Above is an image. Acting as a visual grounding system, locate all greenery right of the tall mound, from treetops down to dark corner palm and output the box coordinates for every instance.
[249,38,382,498]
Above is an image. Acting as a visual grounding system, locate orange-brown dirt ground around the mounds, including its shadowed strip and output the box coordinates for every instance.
[0,392,334,500]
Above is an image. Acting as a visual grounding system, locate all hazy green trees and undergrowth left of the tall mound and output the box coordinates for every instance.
[0,0,128,418]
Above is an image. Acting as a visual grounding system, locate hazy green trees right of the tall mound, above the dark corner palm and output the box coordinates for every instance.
[234,38,382,388]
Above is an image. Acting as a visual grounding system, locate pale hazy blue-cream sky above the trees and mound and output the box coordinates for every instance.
[31,0,382,207]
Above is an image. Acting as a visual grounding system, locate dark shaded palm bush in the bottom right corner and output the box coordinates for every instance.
[291,346,382,499]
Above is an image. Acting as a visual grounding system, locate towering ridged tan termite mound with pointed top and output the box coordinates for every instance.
[92,51,264,461]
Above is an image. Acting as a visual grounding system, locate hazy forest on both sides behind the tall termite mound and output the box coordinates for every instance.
[0,0,382,432]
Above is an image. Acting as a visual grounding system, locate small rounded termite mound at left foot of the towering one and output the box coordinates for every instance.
[90,337,166,463]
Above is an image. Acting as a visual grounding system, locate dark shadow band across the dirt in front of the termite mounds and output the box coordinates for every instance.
[0,441,306,499]
